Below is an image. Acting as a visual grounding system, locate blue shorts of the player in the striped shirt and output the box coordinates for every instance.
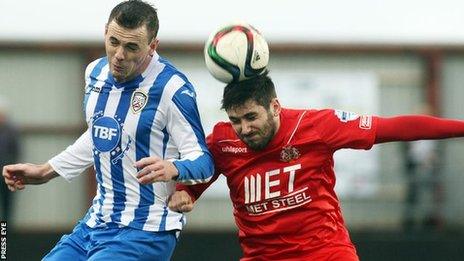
[42,223,177,261]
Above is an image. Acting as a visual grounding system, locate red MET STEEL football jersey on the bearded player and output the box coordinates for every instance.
[177,109,377,260]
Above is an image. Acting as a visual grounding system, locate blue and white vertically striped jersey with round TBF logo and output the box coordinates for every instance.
[49,54,214,231]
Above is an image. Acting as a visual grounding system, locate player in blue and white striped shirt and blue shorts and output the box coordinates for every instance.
[3,0,213,260]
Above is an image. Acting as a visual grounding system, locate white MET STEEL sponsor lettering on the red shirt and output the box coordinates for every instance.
[243,164,312,215]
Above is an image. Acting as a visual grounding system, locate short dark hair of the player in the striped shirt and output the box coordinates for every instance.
[108,0,159,41]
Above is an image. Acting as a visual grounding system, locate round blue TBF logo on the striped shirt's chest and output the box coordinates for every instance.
[92,116,121,152]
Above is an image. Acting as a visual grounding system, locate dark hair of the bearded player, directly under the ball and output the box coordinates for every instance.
[221,73,277,111]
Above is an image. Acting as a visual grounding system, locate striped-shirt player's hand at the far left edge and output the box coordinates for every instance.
[2,163,58,191]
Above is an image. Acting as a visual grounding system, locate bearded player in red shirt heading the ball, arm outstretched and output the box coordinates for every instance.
[169,75,464,261]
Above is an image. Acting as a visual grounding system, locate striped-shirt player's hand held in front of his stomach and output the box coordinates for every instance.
[134,157,179,184]
